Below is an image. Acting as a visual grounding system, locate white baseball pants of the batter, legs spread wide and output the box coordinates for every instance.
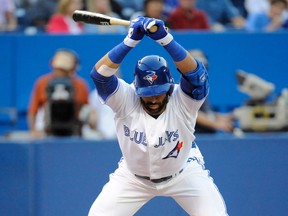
[89,161,228,216]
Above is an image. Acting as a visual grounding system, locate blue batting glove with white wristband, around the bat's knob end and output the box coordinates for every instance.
[143,18,173,46]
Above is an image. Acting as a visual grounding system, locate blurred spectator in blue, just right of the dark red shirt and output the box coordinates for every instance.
[196,0,245,31]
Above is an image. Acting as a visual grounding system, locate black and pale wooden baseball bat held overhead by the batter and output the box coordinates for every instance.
[72,10,158,33]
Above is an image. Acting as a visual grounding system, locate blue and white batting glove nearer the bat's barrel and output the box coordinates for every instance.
[124,16,145,47]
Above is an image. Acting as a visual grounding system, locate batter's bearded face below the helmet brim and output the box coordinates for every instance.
[140,94,168,116]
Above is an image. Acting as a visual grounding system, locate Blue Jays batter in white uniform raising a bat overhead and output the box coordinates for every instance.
[89,17,228,216]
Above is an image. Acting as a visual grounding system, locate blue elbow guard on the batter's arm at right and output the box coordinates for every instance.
[180,60,209,100]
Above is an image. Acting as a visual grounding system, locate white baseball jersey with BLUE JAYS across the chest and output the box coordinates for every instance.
[107,79,204,179]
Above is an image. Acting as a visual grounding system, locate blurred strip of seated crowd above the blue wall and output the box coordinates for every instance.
[0,0,288,34]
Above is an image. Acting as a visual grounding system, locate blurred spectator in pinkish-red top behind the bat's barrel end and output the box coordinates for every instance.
[46,0,83,34]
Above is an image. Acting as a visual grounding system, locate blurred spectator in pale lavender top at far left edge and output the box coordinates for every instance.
[0,0,17,32]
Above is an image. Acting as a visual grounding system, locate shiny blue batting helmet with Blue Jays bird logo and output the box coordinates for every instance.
[134,55,174,97]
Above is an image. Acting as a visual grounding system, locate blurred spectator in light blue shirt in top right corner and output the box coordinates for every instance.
[246,0,288,32]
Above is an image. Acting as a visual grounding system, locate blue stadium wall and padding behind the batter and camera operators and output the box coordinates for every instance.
[0,31,288,216]
